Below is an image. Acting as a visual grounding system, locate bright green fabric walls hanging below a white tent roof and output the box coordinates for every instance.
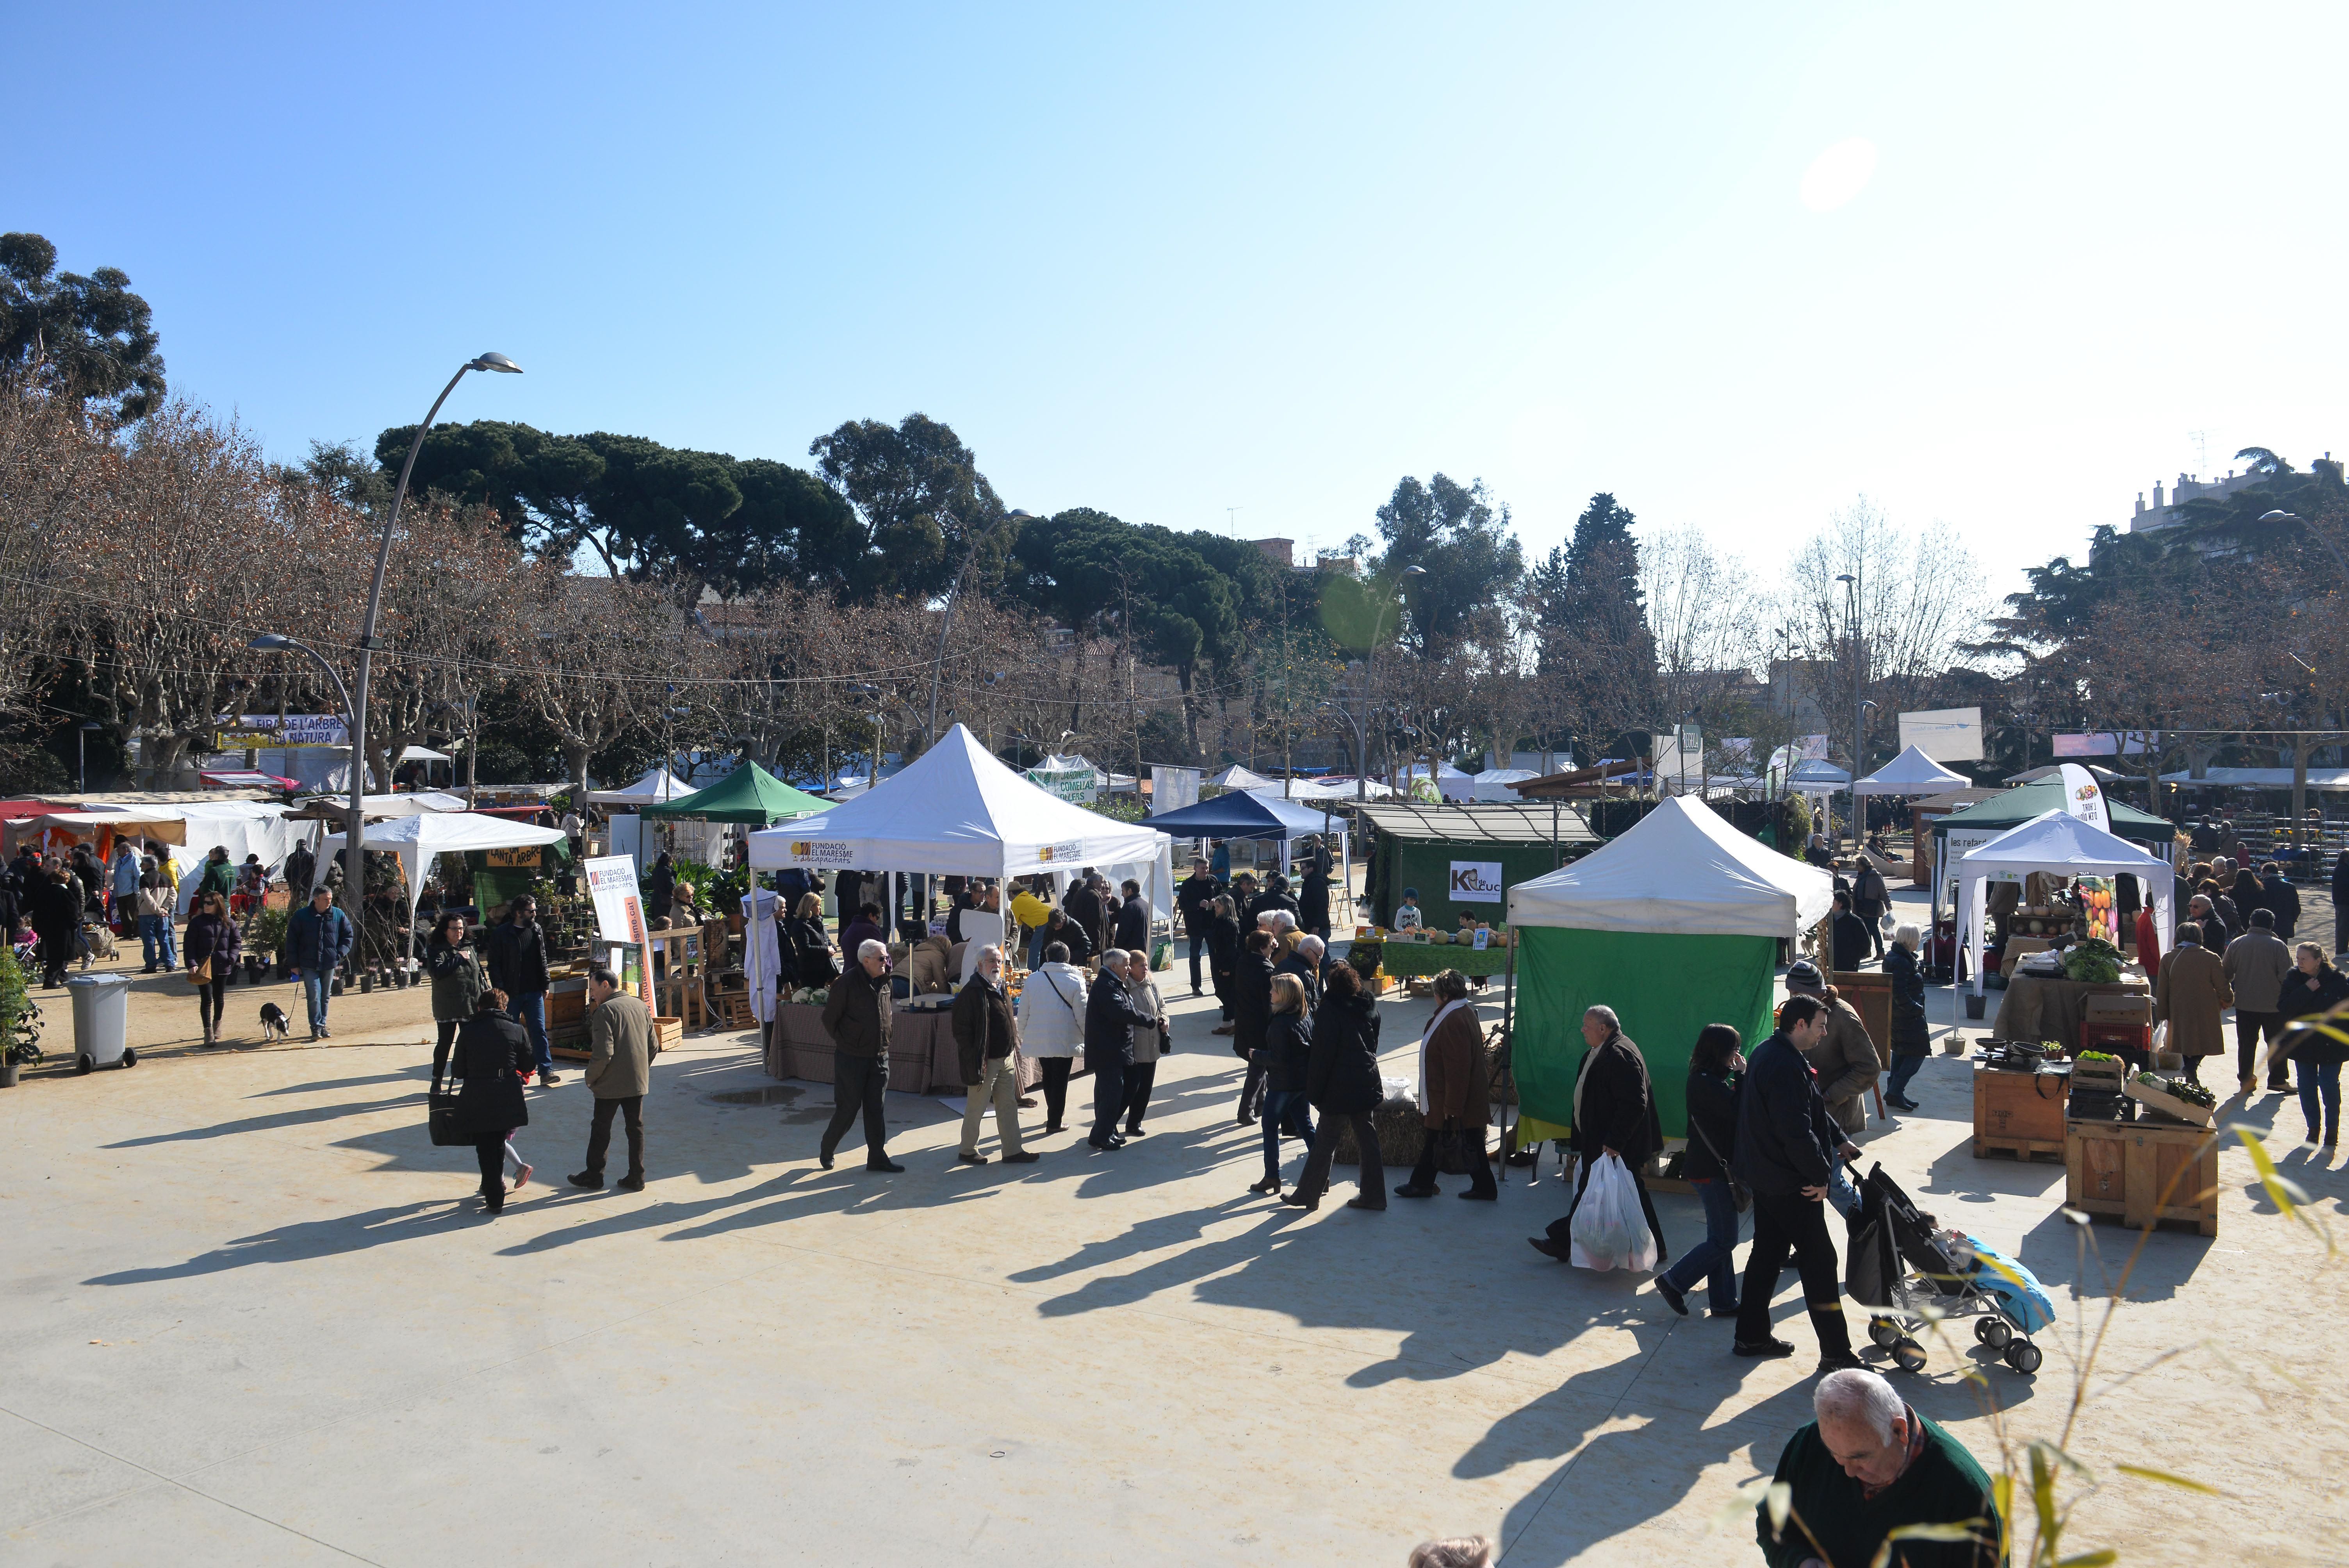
[1513,925,1778,1139]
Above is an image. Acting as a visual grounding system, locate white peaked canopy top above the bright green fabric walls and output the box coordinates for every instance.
[1508,796,1834,941]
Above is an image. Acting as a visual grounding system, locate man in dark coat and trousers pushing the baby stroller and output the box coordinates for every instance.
[1729,995,1861,1371]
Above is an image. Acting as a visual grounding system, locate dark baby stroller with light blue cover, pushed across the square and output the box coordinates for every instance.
[1844,1164,2055,1376]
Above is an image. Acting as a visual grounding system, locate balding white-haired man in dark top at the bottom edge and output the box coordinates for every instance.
[1755,1368,2006,1568]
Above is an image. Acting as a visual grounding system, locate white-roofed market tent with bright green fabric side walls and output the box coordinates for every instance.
[1503,796,1834,1148]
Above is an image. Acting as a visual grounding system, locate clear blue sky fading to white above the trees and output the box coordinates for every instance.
[0,2,2349,587]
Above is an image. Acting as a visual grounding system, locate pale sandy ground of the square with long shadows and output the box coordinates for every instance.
[0,887,2349,1566]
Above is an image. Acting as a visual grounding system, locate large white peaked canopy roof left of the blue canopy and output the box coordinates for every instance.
[747,725,1174,916]
